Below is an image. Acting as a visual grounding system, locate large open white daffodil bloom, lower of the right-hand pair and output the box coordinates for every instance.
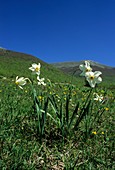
[85,71,102,87]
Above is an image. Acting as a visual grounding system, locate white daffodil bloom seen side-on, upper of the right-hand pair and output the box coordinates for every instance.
[79,61,92,76]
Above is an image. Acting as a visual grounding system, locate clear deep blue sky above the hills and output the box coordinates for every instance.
[0,0,115,66]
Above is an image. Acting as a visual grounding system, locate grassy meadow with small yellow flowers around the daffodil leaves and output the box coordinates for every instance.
[0,76,115,170]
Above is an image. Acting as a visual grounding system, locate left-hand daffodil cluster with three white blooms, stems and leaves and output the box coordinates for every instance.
[15,63,47,137]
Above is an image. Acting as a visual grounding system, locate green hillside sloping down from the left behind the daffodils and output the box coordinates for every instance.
[0,48,76,82]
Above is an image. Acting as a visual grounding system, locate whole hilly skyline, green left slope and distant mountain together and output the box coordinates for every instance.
[0,48,115,88]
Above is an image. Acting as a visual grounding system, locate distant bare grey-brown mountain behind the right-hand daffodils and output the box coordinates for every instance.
[52,60,115,77]
